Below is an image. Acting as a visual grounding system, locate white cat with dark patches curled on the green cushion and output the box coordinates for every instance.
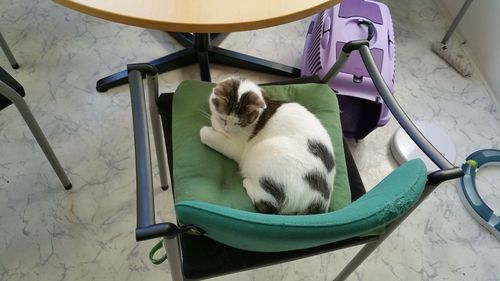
[200,78,335,214]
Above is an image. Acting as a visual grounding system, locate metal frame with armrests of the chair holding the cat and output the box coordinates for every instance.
[128,40,463,281]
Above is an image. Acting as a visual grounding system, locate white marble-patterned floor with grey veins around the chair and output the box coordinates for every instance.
[0,0,500,281]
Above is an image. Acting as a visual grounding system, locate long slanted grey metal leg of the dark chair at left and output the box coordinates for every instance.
[0,81,72,190]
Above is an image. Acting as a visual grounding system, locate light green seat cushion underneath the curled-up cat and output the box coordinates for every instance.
[172,81,351,212]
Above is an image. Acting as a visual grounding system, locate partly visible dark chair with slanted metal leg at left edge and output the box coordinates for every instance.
[0,67,71,190]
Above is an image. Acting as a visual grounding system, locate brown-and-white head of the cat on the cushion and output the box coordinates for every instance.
[209,77,266,133]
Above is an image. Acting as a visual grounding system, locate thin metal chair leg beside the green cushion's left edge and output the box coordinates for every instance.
[147,75,171,190]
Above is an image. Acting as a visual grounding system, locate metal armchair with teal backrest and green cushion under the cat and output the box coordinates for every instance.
[128,40,463,281]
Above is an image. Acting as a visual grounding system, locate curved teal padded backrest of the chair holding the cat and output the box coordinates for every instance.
[176,159,427,252]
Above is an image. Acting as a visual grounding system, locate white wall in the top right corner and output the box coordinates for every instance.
[439,0,500,97]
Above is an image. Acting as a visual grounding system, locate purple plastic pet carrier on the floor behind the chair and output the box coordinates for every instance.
[302,0,395,139]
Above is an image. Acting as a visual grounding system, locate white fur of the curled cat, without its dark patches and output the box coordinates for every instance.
[200,81,336,214]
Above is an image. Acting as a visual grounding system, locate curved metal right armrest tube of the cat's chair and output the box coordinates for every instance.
[359,45,457,170]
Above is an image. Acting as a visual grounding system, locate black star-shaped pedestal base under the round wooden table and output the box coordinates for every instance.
[96,33,300,92]
